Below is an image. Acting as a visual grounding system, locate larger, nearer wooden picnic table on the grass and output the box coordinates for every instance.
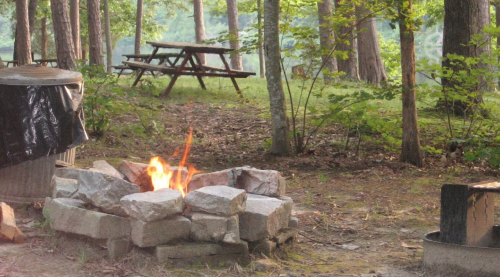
[123,41,255,96]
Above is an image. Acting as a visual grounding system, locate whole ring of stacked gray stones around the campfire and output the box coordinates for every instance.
[44,161,298,264]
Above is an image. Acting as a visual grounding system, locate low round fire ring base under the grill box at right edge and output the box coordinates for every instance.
[423,226,500,276]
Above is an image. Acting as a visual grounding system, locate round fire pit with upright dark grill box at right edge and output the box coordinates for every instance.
[423,182,500,276]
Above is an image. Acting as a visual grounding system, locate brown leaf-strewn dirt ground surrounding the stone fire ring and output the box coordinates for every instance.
[0,102,497,277]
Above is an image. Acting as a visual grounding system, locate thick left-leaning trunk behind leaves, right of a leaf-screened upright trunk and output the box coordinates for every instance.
[356,2,387,84]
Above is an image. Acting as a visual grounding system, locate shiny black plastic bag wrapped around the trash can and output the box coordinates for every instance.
[0,83,88,168]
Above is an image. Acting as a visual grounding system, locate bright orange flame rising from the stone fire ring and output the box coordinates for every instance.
[147,130,201,197]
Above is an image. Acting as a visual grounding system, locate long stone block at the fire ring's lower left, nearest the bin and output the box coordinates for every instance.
[43,198,130,239]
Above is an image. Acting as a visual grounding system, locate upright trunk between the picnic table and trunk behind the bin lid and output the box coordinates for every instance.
[87,0,104,66]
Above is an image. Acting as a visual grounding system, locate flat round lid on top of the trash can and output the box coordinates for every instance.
[0,65,83,86]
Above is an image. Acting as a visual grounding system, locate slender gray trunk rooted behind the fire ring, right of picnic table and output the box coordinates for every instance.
[264,0,290,155]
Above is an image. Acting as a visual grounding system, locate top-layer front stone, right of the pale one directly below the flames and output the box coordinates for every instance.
[184,186,247,216]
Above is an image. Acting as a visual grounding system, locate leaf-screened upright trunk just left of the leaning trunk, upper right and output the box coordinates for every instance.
[335,0,359,81]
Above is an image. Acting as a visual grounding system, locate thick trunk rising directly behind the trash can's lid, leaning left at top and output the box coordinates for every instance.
[50,0,76,70]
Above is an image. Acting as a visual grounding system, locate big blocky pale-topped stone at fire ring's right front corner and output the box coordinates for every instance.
[240,194,292,241]
